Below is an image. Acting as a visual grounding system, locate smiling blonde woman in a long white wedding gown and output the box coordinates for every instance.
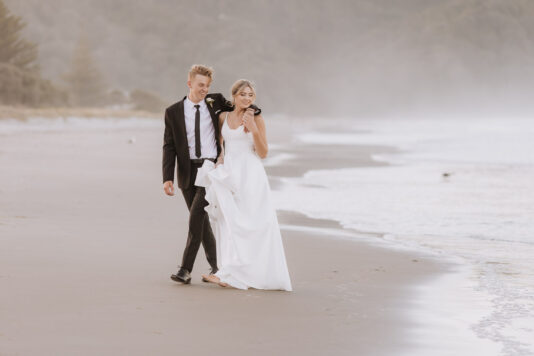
[195,79,292,291]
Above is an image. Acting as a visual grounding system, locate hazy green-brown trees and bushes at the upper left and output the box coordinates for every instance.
[0,0,165,111]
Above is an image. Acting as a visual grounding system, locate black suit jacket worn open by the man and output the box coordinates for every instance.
[162,93,261,189]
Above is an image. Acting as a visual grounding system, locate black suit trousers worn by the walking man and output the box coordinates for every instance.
[181,163,217,272]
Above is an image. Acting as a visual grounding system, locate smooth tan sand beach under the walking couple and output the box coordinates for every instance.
[0,117,454,355]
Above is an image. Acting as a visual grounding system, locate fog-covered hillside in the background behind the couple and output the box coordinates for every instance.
[4,0,534,117]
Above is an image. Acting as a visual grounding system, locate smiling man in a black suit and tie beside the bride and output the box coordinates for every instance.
[162,65,261,284]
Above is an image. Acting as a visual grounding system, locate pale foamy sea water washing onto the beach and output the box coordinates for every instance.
[274,118,534,355]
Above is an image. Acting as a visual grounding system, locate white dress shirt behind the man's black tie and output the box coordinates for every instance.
[184,97,217,159]
